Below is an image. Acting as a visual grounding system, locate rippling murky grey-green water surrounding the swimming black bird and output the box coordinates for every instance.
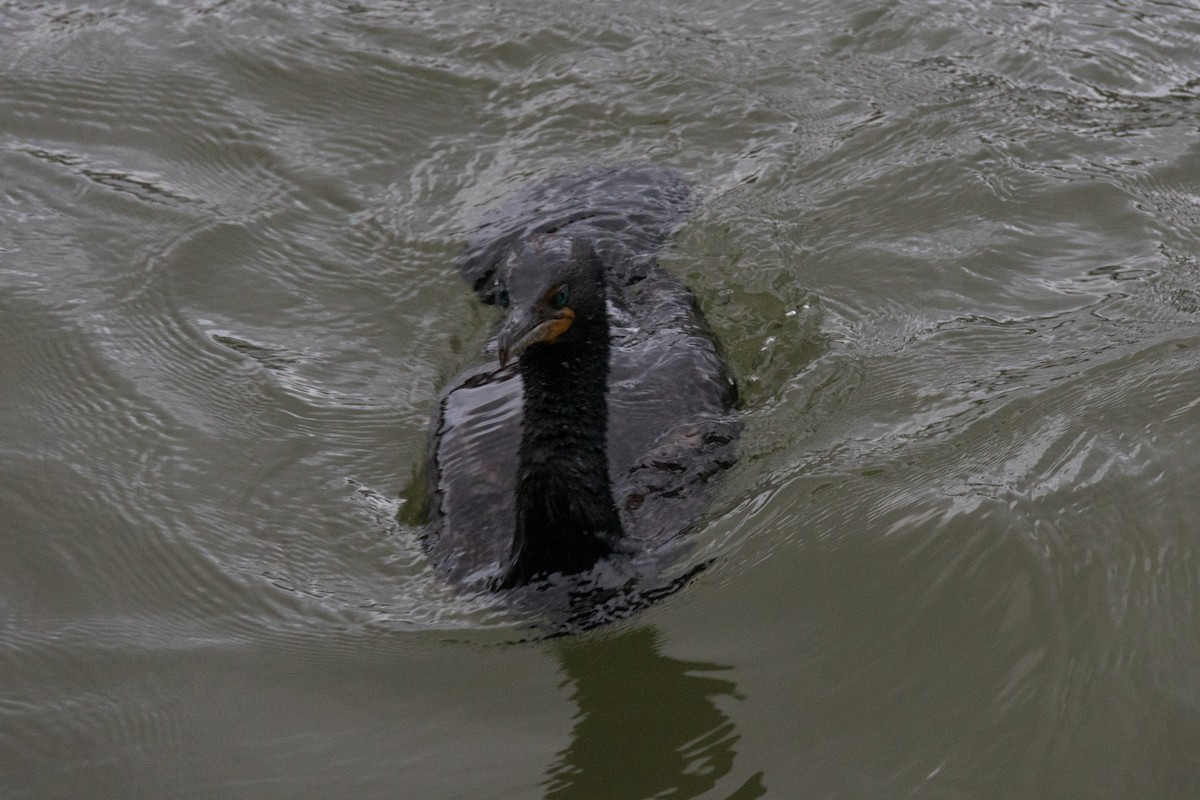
[0,0,1200,799]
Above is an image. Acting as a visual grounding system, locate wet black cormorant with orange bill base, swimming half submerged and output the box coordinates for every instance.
[425,166,739,597]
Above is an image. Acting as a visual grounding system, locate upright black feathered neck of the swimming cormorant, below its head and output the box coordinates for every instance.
[503,315,622,587]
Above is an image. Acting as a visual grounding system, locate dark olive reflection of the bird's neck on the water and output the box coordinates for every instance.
[545,627,766,800]
